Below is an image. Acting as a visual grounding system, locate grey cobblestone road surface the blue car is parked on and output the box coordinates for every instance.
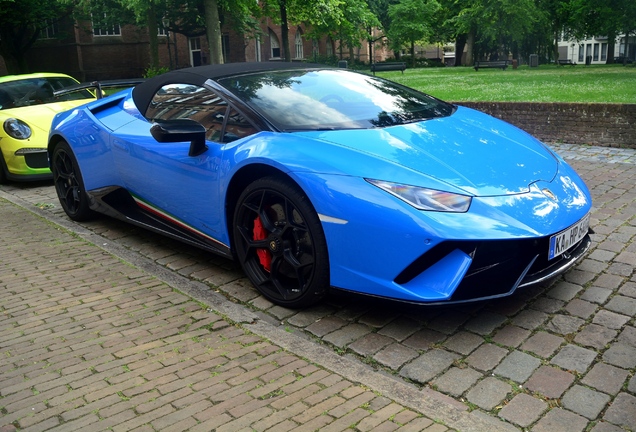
[0,145,636,432]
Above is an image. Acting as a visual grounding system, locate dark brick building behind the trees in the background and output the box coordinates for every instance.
[0,14,387,81]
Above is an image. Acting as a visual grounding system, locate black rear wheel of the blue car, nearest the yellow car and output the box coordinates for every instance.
[51,141,96,222]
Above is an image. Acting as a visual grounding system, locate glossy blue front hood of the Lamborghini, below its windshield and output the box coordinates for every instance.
[294,107,559,197]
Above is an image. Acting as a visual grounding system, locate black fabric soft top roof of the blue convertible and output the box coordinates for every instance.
[132,62,326,113]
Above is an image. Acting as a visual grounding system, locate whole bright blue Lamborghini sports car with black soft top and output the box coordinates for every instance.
[48,63,592,307]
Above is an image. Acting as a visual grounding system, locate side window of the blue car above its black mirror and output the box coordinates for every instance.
[146,84,256,142]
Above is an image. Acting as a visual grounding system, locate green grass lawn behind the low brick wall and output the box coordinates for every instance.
[376,65,636,103]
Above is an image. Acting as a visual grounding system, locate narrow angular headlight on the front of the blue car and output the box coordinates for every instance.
[367,179,472,213]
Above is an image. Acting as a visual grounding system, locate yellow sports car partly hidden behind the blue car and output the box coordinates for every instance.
[0,73,95,183]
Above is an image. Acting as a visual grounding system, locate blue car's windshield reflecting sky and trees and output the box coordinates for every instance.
[219,69,454,131]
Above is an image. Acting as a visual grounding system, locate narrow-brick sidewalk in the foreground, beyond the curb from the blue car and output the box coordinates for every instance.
[0,197,505,432]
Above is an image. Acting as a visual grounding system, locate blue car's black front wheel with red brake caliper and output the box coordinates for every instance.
[233,177,329,308]
